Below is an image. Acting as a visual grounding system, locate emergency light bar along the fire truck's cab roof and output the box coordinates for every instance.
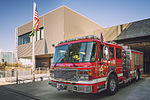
[58,35,101,44]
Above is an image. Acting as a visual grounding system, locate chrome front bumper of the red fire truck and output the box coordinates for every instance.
[49,82,93,93]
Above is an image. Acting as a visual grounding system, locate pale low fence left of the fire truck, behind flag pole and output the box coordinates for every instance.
[0,67,50,84]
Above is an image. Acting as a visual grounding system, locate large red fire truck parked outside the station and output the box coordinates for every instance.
[49,36,143,95]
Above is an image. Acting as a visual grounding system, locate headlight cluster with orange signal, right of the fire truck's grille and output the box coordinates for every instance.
[79,70,93,81]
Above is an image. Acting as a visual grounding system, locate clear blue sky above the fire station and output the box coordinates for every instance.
[0,0,150,51]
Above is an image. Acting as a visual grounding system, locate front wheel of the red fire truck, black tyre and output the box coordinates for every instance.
[107,75,118,95]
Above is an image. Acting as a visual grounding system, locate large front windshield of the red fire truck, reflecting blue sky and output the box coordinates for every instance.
[53,42,97,63]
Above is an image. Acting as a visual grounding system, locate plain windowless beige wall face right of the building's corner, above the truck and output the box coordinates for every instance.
[64,7,103,39]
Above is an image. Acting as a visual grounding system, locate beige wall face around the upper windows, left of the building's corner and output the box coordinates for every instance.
[17,7,64,58]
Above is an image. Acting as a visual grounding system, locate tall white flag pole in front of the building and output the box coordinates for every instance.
[32,2,36,82]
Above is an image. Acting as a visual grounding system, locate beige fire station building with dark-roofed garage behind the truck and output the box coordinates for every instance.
[17,6,150,72]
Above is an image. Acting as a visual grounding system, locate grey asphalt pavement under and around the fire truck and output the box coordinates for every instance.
[0,77,150,100]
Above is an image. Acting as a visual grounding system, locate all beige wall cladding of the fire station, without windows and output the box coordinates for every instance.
[18,6,129,58]
